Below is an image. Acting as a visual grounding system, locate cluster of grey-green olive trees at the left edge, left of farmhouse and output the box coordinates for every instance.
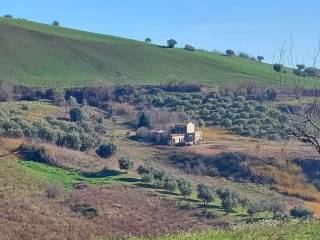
[0,105,107,151]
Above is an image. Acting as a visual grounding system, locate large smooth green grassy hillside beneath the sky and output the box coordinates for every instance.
[0,18,298,87]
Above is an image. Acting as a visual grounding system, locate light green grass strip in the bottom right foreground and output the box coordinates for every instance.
[132,221,320,240]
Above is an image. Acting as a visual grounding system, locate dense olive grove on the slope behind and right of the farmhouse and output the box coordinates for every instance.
[142,89,290,140]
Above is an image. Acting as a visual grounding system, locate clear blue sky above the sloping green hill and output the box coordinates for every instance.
[0,0,320,65]
